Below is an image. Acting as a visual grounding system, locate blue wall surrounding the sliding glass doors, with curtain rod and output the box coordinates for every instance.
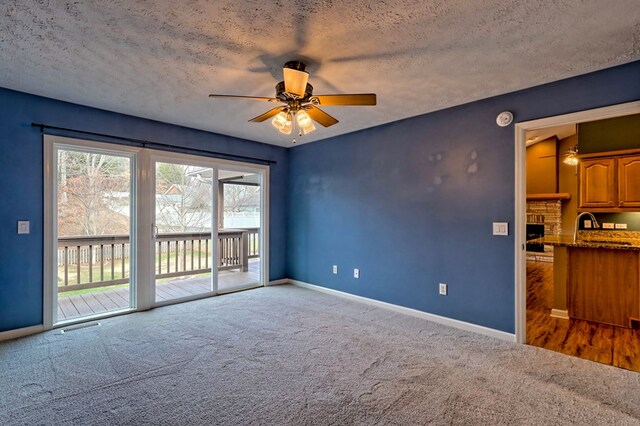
[0,88,288,331]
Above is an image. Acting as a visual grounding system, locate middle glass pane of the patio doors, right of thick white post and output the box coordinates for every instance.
[153,161,216,303]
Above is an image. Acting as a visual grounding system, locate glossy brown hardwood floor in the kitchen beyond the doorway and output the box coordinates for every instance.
[527,262,640,371]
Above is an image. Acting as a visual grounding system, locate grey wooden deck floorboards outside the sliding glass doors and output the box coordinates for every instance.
[58,259,260,321]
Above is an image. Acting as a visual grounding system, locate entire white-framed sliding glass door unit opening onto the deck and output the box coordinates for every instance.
[43,135,269,328]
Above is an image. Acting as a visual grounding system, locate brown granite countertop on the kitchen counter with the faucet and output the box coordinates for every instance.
[527,231,640,251]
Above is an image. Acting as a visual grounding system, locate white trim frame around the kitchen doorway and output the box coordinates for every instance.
[514,101,640,343]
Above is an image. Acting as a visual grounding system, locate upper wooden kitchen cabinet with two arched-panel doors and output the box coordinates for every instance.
[578,154,640,212]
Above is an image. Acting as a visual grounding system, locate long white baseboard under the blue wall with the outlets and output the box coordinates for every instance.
[287,280,516,342]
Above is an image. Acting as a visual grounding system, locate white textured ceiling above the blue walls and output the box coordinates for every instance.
[0,0,640,146]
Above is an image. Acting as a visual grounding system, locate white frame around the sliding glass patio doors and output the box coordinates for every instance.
[42,134,270,330]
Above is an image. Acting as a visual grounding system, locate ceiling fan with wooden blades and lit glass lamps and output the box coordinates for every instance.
[209,61,376,143]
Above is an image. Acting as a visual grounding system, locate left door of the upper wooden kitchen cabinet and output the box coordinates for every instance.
[580,158,617,208]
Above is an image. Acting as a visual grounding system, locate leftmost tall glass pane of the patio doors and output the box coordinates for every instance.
[53,146,135,323]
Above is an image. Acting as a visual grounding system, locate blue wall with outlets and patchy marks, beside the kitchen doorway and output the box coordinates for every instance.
[287,62,640,333]
